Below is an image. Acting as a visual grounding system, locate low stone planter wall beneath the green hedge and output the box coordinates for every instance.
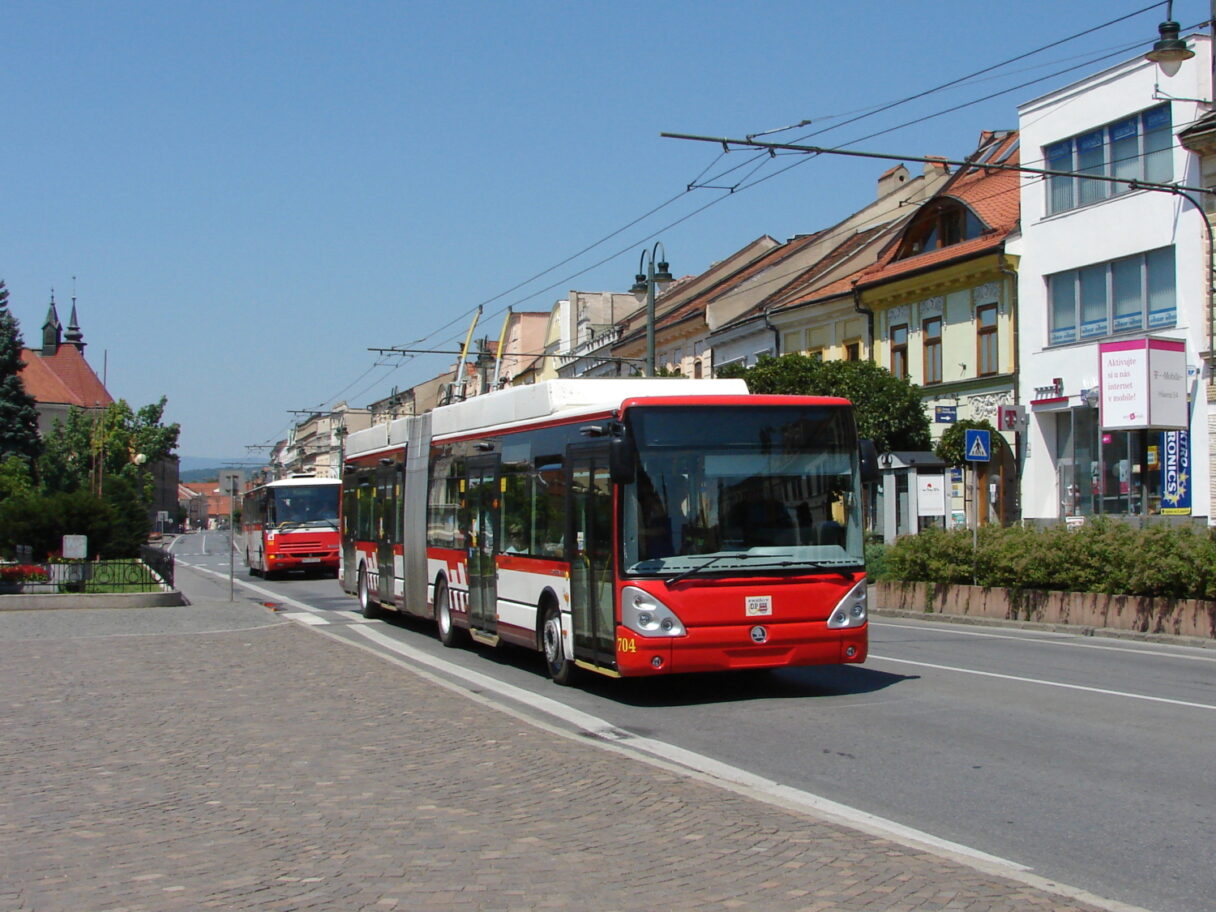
[872,582,1216,638]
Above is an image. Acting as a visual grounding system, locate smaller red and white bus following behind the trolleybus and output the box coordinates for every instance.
[241,475,342,579]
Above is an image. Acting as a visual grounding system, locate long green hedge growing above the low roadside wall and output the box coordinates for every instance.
[871,518,1216,608]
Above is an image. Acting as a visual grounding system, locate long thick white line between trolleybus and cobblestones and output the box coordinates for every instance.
[351,626,1030,872]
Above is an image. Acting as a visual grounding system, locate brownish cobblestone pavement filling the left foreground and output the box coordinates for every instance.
[0,603,1128,912]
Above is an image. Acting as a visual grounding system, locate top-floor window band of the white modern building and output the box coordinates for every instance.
[1043,103,1173,214]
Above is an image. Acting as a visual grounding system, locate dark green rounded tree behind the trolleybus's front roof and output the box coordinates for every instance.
[717,354,929,452]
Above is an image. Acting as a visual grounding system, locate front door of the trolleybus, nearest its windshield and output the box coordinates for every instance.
[565,443,617,668]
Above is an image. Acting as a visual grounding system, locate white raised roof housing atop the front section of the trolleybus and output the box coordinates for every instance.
[430,377,748,438]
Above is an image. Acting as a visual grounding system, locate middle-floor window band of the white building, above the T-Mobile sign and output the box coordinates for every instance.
[1047,247,1177,345]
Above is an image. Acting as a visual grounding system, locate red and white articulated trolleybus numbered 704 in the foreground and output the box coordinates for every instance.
[342,379,872,683]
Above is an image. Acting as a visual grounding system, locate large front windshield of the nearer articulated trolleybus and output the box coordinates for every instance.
[621,405,865,574]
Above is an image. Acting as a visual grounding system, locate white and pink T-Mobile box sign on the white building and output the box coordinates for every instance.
[1098,336,1188,430]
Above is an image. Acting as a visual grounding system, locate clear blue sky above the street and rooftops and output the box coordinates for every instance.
[0,0,1209,458]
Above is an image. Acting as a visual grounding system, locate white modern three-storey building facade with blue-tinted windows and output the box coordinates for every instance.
[1018,35,1212,523]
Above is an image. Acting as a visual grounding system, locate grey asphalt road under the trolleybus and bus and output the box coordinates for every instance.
[174,534,1216,912]
